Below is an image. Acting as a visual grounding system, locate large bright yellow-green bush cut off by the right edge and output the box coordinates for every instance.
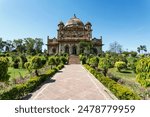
[136,57,150,87]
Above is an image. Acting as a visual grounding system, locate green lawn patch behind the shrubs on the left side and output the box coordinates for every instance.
[8,67,28,78]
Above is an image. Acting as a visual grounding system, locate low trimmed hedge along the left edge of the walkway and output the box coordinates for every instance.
[0,64,64,100]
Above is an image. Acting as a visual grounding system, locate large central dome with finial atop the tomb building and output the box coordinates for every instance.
[65,15,84,28]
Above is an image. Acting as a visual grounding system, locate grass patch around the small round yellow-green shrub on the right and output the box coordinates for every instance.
[108,68,136,81]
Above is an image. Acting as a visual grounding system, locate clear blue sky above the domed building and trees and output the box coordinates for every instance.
[0,0,150,52]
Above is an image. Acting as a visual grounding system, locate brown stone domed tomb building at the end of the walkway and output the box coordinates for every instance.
[47,15,103,55]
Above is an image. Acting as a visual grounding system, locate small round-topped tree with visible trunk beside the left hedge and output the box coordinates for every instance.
[31,56,43,76]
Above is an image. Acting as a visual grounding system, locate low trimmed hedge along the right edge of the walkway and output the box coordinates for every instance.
[84,65,140,100]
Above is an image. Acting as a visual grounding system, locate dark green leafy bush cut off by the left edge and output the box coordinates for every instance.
[0,57,9,82]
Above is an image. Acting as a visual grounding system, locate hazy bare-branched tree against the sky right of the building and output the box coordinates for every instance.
[109,41,122,53]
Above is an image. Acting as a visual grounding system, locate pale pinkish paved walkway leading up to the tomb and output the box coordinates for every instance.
[30,64,112,100]
